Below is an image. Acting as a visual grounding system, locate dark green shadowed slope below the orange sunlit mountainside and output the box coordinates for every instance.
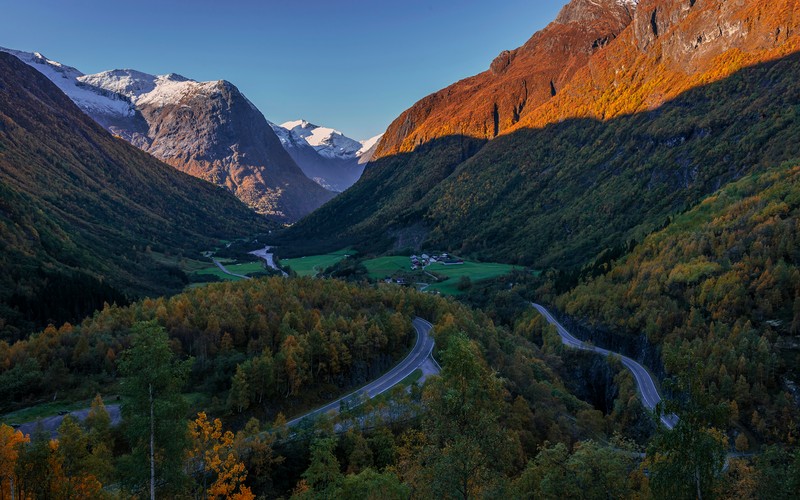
[273,50,800,272]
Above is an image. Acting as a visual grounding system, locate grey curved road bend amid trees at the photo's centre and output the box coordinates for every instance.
[286,318,438,427]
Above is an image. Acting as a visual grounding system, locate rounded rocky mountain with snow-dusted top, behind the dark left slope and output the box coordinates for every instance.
[2,49,333,221]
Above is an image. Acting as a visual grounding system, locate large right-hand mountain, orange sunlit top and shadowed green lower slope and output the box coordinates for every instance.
[280,0,800,269]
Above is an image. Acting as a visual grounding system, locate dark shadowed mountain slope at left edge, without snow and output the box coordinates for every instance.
[0,52,272,340]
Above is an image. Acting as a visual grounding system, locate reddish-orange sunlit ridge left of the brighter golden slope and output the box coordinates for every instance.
[375,0,635,159]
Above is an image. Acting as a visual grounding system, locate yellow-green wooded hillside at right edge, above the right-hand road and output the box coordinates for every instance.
[556,165,800,443]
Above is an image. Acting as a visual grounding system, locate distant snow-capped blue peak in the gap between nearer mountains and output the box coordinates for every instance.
[270,120,381,192]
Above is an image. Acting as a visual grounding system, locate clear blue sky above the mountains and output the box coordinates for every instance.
[0,0,566,139]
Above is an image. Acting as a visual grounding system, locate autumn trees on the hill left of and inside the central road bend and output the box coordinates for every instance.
[0,278,414,416]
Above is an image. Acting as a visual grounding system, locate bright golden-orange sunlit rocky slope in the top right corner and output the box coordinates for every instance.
[508,0,800,132]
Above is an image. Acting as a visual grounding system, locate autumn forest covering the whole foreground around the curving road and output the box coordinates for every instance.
[0,272,800,498]
